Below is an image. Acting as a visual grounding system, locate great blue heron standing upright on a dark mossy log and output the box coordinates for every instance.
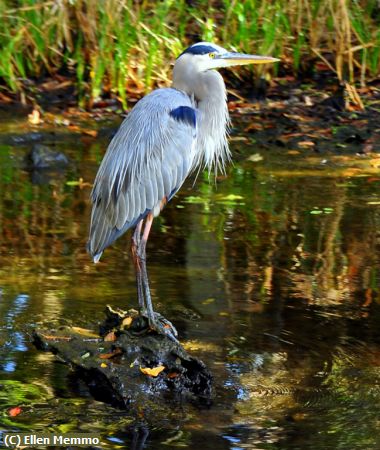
[88,42,278,339]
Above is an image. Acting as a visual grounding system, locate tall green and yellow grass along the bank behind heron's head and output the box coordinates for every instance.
[0,0,380,108]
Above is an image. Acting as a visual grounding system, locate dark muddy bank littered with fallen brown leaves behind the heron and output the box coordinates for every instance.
[0,78,380,159]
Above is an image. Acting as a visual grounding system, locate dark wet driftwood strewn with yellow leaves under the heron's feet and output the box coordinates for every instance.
[34,307,211,410]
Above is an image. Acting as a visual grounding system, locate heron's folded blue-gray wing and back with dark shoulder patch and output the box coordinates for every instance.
[88,88,196,261]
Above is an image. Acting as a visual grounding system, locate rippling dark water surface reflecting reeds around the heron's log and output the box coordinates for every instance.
[0,117,380,450]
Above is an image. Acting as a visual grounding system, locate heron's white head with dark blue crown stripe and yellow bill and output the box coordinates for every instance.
[177,42,279,72]
